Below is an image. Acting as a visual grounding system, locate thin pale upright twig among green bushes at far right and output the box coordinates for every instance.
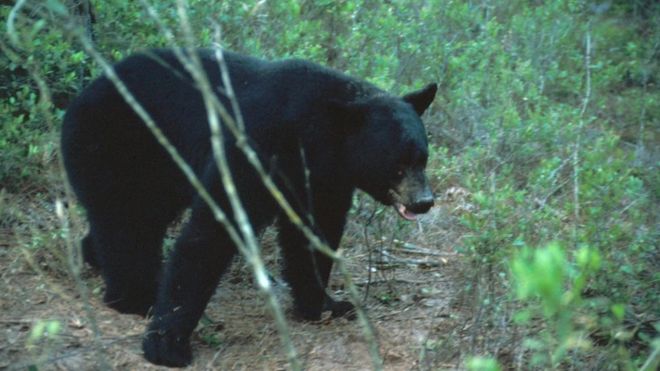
[573,24,591,247]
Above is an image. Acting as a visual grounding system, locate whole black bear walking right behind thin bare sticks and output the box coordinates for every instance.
[62,49,437,366]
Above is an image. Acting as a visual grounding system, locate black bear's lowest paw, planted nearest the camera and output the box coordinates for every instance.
[142,331,192,367]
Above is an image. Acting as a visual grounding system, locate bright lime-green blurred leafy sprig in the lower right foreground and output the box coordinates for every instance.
[511,243,600,368]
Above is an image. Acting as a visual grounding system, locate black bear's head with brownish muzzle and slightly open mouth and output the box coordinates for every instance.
[339,84,437,220]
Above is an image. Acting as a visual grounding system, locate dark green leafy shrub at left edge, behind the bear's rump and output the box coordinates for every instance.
[0,6,82,192]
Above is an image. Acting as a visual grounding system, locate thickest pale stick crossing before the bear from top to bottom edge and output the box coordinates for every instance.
[177,0,302,370]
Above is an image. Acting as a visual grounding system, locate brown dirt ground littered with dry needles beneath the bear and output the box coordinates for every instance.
[0,193,474,370]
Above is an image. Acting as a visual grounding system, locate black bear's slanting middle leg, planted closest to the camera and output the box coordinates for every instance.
[142,215,235,367]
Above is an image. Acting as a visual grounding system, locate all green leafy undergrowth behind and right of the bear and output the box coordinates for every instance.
[0,0,660,370]
